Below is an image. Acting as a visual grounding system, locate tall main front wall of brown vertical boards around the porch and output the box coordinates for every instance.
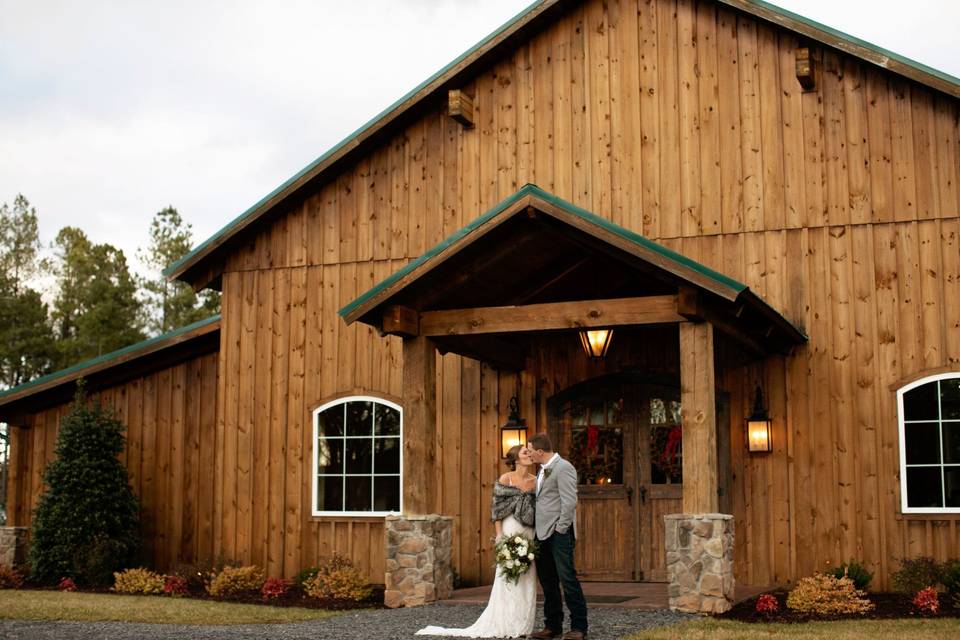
[214,0,960,587]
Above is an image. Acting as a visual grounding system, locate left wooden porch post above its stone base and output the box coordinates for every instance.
[403,336,439,515]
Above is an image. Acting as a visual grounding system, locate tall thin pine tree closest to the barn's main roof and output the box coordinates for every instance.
[140,207,220,334]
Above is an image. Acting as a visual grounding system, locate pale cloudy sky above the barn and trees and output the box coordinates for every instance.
[0,0,960,278]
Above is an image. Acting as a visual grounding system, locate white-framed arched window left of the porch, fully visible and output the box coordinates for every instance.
[313,396,403,516]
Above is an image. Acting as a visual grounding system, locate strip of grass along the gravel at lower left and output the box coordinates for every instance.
[0,590,338,624]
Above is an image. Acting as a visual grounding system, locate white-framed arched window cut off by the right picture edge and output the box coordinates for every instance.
[897,373,960,513]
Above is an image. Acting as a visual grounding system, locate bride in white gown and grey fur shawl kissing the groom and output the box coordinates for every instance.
[417,446,537,638]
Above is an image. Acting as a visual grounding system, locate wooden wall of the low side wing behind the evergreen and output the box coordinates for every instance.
[9,353,217,571]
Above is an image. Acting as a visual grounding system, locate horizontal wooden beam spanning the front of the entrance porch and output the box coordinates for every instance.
[420,296,685,336]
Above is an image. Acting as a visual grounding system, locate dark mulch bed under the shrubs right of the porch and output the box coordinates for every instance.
[715,591,960,624]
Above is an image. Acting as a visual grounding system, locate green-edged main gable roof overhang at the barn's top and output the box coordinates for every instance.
[164,0,960,286]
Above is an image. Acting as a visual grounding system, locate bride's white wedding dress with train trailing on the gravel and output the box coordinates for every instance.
[417,482,537,638]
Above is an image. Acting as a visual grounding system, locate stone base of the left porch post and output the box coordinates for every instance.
[383,515,453,608]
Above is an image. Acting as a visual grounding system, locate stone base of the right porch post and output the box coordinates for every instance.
[663,513,734,613]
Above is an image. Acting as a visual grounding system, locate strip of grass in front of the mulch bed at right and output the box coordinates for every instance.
[629,618,960,640]
